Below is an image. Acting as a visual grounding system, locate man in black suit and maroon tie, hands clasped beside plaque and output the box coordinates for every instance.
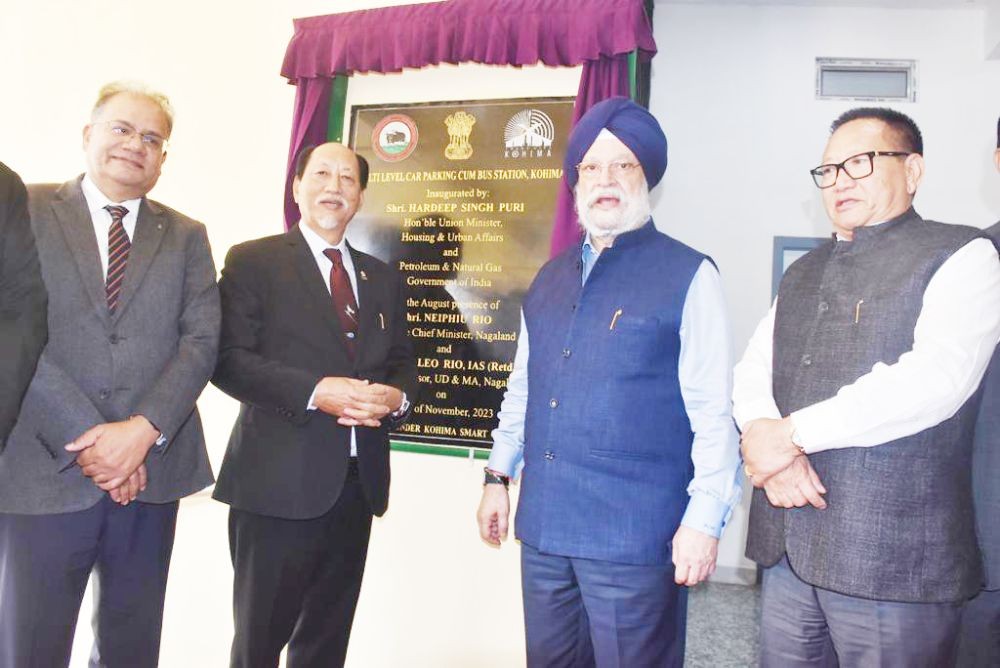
[212,143,416,668]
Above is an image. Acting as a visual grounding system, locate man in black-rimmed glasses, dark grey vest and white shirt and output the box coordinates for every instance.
[733,108,1000,668]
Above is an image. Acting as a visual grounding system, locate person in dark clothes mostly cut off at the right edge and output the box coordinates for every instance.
[958,118,1000,668]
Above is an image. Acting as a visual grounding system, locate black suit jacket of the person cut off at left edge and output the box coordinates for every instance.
[0,163,48,451]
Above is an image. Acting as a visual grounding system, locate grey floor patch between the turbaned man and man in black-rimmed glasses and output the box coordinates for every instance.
[684,582,760,668]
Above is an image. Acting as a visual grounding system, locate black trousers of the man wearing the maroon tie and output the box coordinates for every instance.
[229,464,372,668]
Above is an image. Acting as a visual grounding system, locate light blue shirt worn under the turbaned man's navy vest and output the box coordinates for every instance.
[488,235,742,538]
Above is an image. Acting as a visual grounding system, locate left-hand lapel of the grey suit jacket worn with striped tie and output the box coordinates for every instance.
[52,177,109,321]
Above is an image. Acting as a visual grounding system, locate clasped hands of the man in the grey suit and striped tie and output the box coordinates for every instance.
[66,415,159,505]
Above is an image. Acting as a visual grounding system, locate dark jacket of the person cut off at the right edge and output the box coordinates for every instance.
[972,223,1000,590]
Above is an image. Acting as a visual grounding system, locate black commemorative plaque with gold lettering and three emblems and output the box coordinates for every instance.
[348,98,573,448]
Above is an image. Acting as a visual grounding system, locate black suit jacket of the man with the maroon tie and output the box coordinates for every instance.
[212,227,416,519]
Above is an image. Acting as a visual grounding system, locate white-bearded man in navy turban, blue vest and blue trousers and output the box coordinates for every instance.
[478,98,740,668]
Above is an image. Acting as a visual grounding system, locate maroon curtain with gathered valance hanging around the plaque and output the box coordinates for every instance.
[281,0,656,245]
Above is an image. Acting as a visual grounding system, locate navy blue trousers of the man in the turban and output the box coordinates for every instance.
[521,543,687,668]
